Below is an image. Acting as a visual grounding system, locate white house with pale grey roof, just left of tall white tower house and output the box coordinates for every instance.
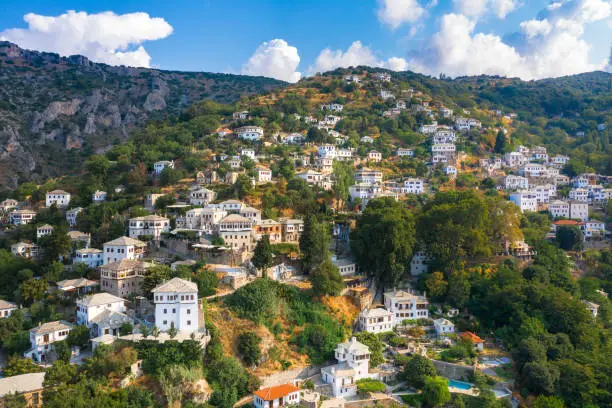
[76,292,132,337]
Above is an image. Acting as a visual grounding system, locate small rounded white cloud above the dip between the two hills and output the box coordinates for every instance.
[242,39,302,82]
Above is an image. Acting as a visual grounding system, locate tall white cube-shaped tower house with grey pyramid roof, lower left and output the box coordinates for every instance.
[151,278,200,333]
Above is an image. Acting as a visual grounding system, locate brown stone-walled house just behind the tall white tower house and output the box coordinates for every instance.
[100,259,153,298]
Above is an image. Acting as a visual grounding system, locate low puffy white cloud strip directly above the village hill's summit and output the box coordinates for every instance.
[309,41,408,74]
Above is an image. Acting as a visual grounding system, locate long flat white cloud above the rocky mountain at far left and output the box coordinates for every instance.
[0,10,172,67]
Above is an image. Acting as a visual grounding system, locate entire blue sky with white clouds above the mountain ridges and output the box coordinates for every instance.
[0,0,612,82]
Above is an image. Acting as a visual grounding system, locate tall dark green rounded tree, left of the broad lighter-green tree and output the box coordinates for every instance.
[350,197,416,287]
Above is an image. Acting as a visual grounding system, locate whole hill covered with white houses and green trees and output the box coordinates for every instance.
[0,68,612,408]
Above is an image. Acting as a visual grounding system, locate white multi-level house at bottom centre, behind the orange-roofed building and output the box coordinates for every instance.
[321,337,371,397]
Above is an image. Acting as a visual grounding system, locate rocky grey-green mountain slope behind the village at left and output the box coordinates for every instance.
[0,42,286,188]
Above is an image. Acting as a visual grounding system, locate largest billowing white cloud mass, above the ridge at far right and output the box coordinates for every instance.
[408,0,612,79]
